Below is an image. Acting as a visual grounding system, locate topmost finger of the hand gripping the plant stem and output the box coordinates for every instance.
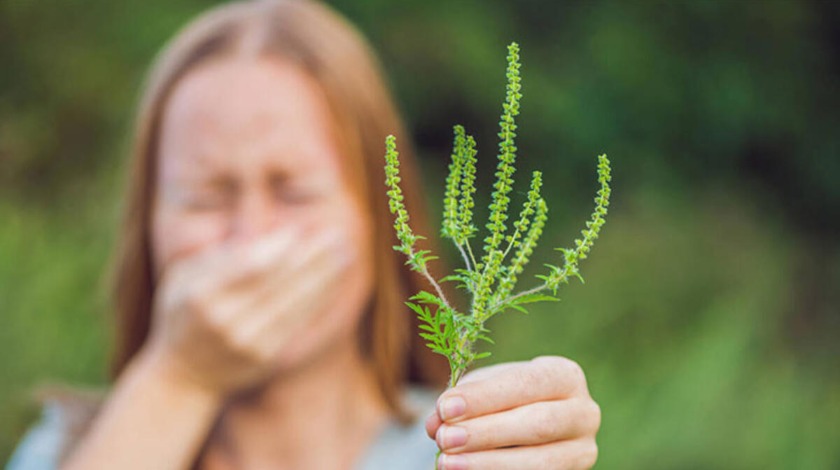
[437,356,589,423]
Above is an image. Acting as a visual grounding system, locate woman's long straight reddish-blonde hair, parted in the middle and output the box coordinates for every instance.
[112,0,447,416]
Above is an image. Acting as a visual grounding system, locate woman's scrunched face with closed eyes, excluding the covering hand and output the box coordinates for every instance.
[152,58,373,366]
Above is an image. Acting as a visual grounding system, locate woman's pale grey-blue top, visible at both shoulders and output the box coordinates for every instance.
[6,388,437,470]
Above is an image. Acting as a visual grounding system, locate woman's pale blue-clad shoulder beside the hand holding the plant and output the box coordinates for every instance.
[357,387,439,470]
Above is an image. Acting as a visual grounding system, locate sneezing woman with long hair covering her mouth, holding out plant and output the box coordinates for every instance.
[11,0,600,469]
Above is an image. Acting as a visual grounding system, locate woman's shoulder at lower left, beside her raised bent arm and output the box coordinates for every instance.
[6,392,101,470]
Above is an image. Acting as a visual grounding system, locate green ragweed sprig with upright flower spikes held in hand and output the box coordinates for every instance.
[385,43,611,387]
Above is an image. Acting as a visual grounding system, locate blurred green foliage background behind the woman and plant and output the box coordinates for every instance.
[0,0,840,469]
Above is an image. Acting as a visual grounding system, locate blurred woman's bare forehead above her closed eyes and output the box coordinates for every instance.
[160,57,339,173]
